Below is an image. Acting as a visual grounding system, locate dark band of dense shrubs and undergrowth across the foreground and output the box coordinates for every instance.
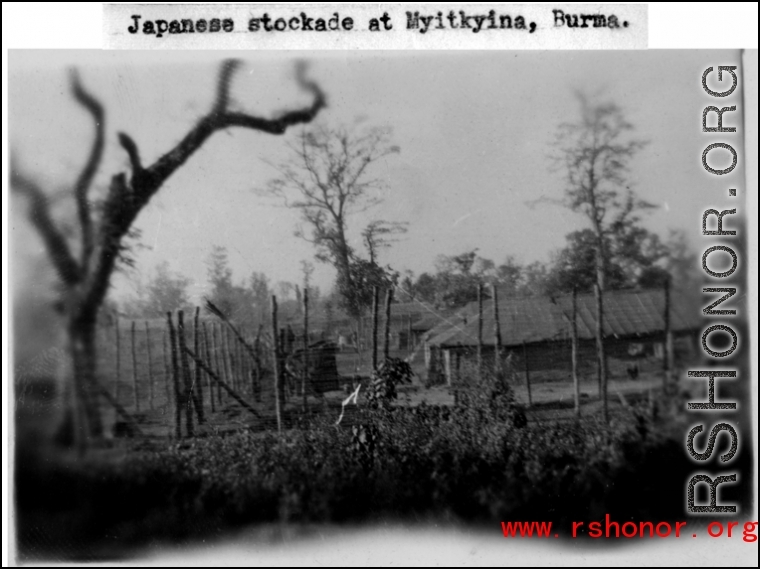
[16,370,704,557]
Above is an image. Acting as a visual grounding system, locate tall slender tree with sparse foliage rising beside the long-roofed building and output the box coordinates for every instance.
[552,93,653,419]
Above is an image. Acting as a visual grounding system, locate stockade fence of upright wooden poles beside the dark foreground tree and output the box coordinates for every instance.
[99,291,412,438]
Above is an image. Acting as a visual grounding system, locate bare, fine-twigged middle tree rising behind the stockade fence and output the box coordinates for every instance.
[262,126,399,318]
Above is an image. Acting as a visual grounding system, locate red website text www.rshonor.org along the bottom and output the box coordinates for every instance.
[501,514,757,543]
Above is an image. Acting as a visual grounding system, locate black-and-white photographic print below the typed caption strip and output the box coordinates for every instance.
[9,47,757,562]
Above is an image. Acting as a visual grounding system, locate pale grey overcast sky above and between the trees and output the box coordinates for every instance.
[9,50,744,304]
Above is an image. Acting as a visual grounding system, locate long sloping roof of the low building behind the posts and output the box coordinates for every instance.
[429,289,700,347]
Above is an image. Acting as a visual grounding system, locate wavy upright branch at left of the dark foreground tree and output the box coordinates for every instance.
[71,71,105,267]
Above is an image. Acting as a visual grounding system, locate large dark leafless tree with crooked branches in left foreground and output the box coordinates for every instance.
[11,60,325,445]
